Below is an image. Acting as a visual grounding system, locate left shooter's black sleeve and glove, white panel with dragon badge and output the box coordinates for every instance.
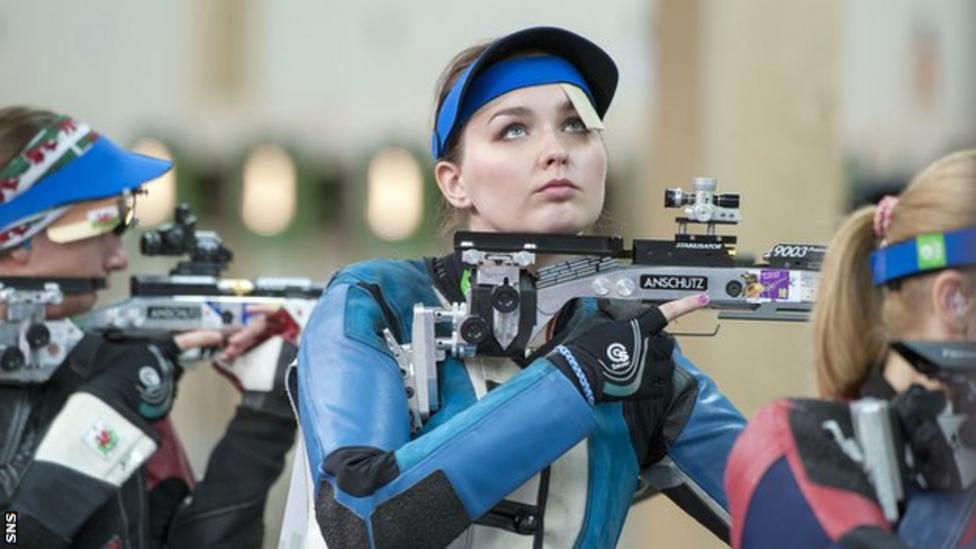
[8,344,172,547]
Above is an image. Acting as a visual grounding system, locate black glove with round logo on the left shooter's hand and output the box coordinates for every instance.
[80,339,181,421]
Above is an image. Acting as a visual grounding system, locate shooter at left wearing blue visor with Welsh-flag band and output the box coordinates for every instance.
[0,107,295,548]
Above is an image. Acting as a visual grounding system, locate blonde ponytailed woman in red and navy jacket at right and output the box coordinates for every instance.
[726,150,976,548]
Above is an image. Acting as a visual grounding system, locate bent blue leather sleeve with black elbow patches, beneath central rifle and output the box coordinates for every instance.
[297,274,596,547]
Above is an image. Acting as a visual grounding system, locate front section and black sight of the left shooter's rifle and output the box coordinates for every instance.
[76,204,323,337]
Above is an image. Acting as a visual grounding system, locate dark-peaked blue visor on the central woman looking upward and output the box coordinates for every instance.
[430,27,619,159]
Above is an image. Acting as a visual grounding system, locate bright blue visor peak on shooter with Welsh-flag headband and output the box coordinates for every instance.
[0,135,172,228]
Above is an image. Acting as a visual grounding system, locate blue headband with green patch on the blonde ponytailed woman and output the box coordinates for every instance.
[871,227,976,286]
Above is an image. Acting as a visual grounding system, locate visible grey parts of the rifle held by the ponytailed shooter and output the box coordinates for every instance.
[824,341,976,522]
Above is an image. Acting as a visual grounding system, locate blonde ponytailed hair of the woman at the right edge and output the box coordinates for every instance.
[813,149,976,398]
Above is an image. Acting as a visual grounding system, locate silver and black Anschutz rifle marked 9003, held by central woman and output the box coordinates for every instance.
[385,177,825,428]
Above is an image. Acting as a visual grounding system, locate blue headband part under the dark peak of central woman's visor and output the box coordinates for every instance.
[430,55,595,159]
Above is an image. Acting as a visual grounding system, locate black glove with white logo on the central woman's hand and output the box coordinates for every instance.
[547,307,674,404]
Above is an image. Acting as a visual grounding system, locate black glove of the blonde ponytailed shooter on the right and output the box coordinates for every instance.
[892,385,961,490]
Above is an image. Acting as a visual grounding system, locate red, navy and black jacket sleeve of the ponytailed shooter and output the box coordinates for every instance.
[725,400,906,549]
